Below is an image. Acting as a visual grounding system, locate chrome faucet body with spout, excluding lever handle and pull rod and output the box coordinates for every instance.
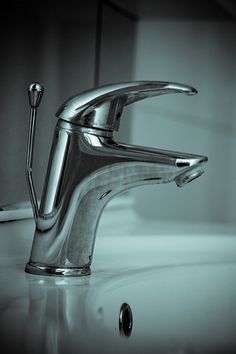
[26,81,207,276]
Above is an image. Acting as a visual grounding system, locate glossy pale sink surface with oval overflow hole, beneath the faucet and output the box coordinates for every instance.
[0,220,236,354]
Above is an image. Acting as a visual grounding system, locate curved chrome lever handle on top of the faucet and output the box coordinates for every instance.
[56,81,197,131]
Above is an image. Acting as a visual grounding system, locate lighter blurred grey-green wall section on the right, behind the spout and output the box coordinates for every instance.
[132,19,236,222]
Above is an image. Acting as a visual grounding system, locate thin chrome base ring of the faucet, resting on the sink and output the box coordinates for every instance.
[25,261,91,277]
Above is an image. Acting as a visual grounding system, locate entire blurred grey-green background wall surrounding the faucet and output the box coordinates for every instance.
[0,0,236,224]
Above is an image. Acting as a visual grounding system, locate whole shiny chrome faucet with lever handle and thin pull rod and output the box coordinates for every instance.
[25,81,207,276]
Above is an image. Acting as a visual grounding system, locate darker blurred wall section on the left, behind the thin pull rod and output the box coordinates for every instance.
[0,0,137,204]
